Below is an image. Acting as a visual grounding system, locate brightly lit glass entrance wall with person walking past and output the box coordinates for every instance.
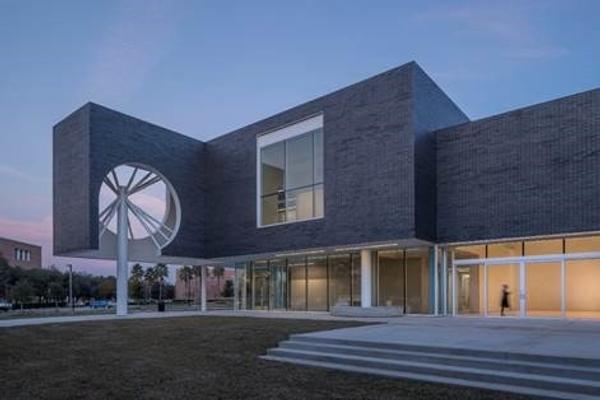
[447,235,600,318]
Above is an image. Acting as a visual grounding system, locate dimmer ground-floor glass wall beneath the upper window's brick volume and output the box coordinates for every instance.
[235,248,431,313]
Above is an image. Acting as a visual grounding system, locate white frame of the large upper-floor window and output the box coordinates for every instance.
[256,113,325,228]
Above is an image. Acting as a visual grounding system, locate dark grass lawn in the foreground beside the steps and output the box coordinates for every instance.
[0,317,524,400]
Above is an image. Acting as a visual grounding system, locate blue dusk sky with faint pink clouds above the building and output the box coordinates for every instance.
[0,0,600,275]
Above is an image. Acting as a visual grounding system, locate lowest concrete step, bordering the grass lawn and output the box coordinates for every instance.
[261,355,598,400]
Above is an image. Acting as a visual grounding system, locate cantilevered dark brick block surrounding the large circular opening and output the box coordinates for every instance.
[54,103,206,257]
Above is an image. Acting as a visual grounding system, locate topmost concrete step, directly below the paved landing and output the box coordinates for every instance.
[289,334,600,369]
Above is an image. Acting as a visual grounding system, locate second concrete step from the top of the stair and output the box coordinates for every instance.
[279,340,600,382]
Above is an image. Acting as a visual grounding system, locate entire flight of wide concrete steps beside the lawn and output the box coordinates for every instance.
[262,335,600,400]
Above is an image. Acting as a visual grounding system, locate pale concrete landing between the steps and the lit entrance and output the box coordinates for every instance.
[305,317,600,359]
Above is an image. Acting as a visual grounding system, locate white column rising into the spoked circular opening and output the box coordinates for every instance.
[117,186,129,315]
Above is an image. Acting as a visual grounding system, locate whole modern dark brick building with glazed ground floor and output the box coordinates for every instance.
[54,62,600,317]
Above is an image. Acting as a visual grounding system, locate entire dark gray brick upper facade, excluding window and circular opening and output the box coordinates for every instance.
[54,63,600,258]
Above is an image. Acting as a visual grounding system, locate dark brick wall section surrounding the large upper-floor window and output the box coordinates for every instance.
[206,65,415,257]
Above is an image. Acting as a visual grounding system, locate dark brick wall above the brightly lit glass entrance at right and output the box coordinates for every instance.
[436,90,600,242]
